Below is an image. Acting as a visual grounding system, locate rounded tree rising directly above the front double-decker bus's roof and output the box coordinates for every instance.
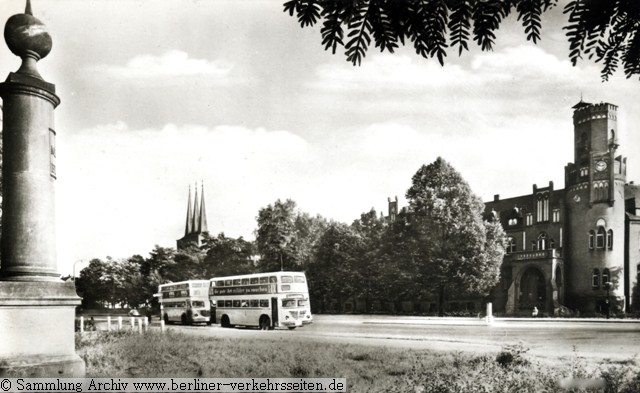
[256,199,300,271]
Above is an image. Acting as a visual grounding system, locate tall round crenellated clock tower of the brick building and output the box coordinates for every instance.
[565,100,626,311]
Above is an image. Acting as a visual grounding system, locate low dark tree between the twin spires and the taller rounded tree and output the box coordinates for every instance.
[204,233,255,278]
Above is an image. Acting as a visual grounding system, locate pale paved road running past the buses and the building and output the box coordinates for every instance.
[89,315,640,363]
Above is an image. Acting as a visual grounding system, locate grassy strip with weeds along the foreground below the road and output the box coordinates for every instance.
[76,332,640,393]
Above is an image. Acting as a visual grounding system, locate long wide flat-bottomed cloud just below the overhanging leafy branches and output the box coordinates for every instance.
[308,45,599,93]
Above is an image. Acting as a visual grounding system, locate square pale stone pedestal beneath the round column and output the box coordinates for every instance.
[0,280,85,378]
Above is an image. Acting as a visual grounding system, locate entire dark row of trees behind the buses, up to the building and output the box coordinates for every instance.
[76,158,505,313]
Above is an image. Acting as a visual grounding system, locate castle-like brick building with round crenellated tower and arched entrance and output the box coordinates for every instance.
[485,101,640,315]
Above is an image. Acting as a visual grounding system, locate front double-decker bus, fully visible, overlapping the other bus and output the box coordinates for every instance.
[209,272,313,330]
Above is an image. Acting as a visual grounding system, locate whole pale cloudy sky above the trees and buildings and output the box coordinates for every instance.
[0,0,640,274]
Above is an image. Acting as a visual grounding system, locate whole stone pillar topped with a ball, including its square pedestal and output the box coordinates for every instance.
[0,0,85,377]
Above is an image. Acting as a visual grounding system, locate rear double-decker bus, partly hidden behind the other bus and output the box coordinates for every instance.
[158,280,211,325]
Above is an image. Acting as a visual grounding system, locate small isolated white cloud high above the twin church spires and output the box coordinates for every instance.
[90,50,233,80]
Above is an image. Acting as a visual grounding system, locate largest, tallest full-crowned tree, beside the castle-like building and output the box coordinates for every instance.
[406,157,504,314]
